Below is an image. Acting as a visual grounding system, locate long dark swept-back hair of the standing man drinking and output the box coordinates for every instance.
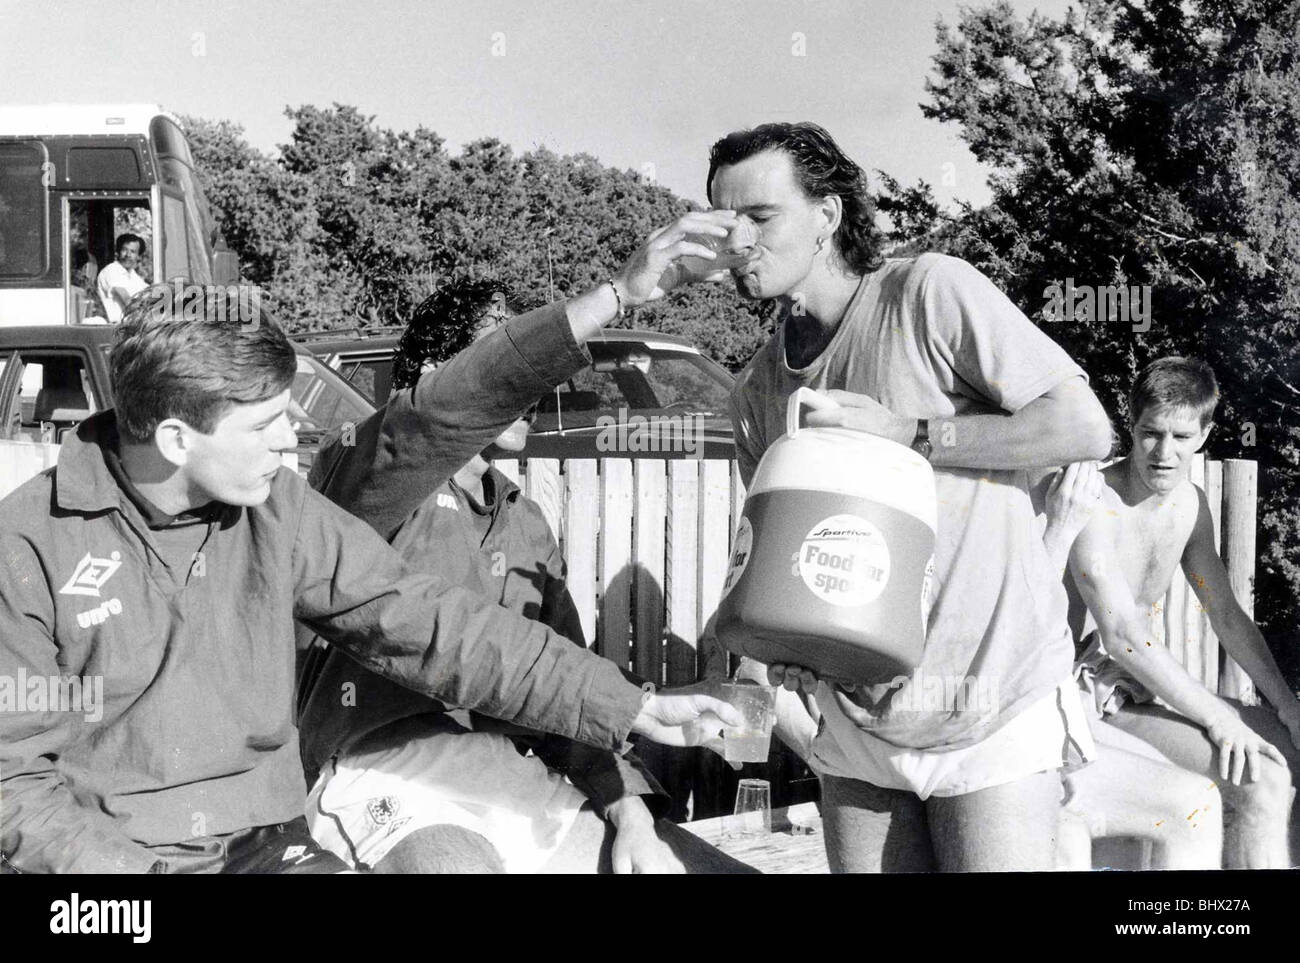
[705,122,884,274]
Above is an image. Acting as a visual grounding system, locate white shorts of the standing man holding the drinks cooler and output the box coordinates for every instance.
[813,678,1097,799]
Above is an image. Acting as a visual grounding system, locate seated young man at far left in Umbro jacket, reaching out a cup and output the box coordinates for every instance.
[0,236,738,872]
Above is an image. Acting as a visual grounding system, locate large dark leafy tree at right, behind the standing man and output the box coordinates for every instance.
[915,0,1300,676]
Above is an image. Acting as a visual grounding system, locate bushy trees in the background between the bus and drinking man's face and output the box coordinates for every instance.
[186,104,770,368]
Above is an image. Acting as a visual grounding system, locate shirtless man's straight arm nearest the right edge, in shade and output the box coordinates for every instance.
[1182,489,1300,747]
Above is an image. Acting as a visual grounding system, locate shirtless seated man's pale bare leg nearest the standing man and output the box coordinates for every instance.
[1063,720,1223,869]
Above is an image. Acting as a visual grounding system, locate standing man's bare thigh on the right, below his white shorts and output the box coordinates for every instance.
[926,769,1061,872]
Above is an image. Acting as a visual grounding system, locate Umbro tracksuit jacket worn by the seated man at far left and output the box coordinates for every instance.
[0,304,641,872]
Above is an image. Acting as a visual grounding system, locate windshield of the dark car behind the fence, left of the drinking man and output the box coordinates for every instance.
[566,343,731,416]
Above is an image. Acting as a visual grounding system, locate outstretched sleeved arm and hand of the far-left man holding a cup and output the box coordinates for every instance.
[295,488,742,751]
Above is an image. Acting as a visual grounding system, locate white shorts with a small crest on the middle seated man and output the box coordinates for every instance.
[307,732,586,873]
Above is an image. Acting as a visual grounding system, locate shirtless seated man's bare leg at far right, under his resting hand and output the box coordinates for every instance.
[1106,699,1295,869]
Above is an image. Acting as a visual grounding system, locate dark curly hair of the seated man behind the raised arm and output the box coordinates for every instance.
[393,270,502,390]
